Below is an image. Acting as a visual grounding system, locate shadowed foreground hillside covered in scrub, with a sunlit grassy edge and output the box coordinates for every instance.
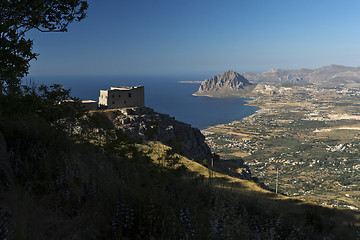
[0,86,358,239]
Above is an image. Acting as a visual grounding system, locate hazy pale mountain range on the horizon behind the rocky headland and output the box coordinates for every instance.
[243,65,360,85]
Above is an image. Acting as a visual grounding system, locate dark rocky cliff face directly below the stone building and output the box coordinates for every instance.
[95,107,212,162]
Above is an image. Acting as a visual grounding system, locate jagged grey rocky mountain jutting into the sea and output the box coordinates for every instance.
[194,70,252,97]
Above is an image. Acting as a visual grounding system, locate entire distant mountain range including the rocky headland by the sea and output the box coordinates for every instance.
[193,65,360,97]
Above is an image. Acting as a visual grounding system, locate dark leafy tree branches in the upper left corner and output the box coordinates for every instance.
[0,0,88,96]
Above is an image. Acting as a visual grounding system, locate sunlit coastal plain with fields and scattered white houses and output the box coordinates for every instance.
[203,86,360,210]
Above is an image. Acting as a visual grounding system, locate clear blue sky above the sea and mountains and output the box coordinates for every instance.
[28,0,360,76]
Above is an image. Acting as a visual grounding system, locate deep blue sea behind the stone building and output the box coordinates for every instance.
[27,76,259,129]
